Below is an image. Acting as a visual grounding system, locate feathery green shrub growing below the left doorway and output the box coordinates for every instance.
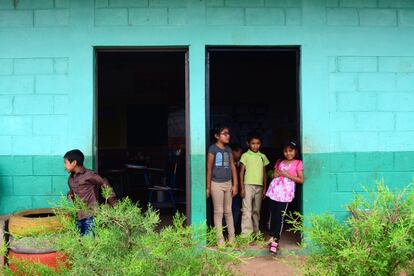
[5,190,258,275]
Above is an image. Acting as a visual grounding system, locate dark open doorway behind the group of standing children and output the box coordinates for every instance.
[206,47,302,244]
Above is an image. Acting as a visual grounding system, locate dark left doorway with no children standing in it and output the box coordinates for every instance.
[95,48,190,225]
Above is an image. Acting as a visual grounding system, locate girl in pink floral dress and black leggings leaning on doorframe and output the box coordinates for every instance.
[266,141,304,254]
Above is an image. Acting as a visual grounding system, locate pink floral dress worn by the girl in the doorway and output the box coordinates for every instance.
[266,159,303,202]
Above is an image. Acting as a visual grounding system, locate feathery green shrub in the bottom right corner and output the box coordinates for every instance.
[288,182,414,275]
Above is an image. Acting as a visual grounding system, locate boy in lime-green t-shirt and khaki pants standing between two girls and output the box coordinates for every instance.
[240,134,269,235]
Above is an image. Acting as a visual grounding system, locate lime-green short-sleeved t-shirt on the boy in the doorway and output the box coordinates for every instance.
[240,150,269,185]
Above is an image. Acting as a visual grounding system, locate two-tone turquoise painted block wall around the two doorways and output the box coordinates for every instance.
[0,0,414,223]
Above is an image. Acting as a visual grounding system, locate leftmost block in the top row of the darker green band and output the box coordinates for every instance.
[0,155,33,176]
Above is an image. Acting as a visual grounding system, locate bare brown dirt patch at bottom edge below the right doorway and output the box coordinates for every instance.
[233,256,303,276]
